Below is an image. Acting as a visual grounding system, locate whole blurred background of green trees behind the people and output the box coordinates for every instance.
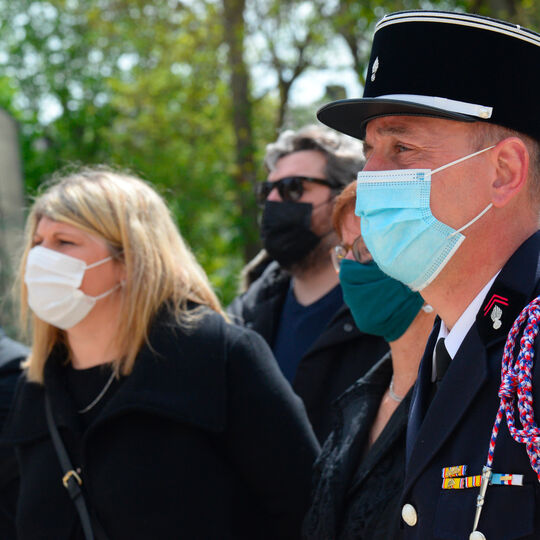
[0,0,540,333]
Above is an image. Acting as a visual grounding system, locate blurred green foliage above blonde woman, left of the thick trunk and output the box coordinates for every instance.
[0,0,255,302]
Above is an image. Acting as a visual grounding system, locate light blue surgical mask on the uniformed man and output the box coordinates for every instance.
[356,146,494,291]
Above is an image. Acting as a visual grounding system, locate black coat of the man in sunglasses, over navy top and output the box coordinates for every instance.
[228,262,388,443]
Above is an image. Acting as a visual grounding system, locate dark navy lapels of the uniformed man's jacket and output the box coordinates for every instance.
[405,325,488,491]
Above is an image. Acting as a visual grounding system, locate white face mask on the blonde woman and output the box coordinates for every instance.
[24,246,120,330]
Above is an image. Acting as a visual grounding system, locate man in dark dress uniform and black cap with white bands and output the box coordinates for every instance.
[318,11,540,540]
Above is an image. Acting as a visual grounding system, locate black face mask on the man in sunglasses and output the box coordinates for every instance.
[261,201,321,268]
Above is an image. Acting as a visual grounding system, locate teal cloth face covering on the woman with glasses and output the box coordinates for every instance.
[339,259,424,341]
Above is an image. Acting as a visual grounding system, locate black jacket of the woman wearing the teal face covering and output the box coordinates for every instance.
[304,353,411,540]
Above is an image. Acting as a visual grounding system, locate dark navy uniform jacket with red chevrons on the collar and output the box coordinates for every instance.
[402,233,540,540]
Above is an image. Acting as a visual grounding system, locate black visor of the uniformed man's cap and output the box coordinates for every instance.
[317,98,480,139]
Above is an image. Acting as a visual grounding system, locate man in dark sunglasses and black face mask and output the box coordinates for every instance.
[228,126,387,442]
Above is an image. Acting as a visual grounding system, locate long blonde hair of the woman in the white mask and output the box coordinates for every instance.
[19,168,224,383]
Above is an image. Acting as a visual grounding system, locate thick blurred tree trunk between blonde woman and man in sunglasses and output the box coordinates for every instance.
[223,0,259,261]
